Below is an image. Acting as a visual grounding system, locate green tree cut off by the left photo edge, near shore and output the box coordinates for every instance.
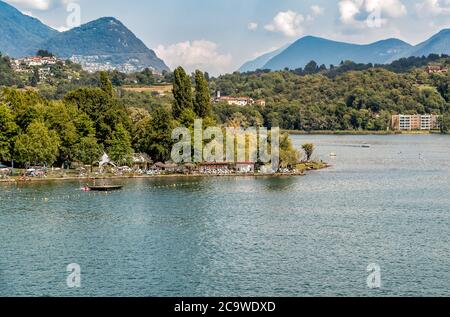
[0,103,18,161]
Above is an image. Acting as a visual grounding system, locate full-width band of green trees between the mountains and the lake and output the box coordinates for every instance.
[0,52,450,166]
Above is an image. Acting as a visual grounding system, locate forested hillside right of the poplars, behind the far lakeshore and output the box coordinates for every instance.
[210,58,450,131]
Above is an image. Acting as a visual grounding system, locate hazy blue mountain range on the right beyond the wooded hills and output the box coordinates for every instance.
[239,29,450,72]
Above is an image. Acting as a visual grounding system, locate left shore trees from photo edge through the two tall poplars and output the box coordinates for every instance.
[0,68,220,166]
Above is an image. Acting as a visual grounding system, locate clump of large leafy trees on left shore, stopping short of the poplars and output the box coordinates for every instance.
[0,74,132,166]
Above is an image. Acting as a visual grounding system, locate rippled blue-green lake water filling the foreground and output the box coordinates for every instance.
[0,135,450,296]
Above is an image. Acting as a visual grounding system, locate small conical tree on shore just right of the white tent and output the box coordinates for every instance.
[108,124,133,164]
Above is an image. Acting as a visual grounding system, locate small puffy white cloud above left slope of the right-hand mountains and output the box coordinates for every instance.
[264,10,305,37]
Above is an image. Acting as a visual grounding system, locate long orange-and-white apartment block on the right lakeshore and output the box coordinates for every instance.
[391,114,440,131]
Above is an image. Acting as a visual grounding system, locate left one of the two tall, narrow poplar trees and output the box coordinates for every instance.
[172,66,194,119]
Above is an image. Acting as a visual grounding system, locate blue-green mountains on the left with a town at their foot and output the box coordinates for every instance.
[0,0,169,72]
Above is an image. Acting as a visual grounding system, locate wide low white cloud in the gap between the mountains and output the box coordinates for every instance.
[155,40,233,75]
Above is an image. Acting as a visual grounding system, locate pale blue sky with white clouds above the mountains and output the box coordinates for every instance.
[6,0,450,75]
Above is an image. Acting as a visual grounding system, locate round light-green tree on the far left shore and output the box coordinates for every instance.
[14,121,60,165]
